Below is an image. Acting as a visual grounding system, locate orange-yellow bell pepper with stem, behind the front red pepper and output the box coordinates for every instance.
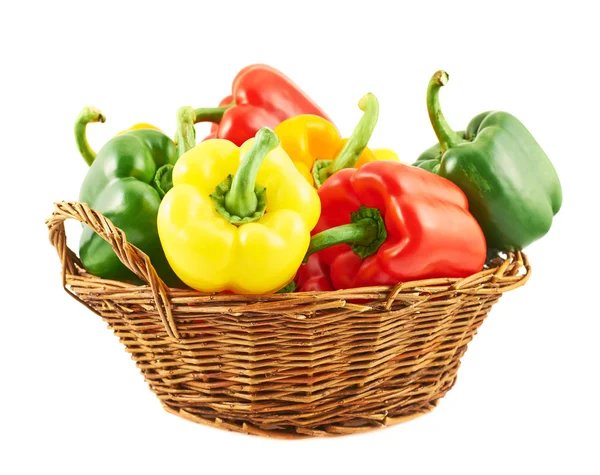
[274,94,399,188]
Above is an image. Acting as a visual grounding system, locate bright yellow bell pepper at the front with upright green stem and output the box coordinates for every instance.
[158,123,321,294]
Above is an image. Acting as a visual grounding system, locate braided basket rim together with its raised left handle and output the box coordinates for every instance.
[45,201,531,332]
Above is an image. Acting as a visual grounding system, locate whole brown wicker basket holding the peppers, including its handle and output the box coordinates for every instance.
[46,202,530,438]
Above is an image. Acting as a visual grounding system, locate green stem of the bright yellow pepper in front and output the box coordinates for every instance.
[225,127,279,218]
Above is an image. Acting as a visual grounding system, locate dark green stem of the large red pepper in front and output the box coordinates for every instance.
[303,206,387,262]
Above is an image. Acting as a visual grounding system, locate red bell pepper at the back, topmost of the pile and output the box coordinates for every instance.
[194,64,331,146]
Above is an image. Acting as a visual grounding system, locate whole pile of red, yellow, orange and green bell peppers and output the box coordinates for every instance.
[75,64,562,295]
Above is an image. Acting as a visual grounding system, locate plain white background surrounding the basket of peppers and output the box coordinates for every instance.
[0,0,600,475]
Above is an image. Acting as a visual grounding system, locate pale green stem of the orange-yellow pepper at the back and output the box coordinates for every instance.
[319,93,379,184]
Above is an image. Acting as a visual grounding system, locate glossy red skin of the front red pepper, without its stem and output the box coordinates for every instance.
[312,161,486,289]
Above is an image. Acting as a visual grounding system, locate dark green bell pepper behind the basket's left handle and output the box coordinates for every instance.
[75,107,183,287]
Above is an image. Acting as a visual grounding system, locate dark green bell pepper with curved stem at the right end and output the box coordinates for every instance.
[414,71,562,253]
